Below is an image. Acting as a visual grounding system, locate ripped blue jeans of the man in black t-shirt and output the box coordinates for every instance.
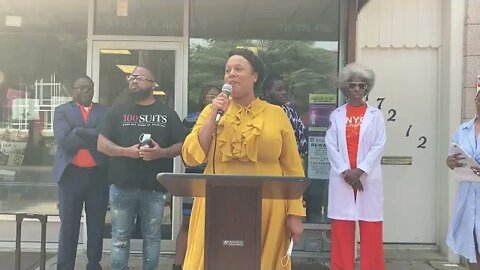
[110,185,166,270]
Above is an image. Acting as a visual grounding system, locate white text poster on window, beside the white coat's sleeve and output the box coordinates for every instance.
[307,136,330,179]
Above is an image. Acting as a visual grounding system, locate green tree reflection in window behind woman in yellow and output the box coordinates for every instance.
[189,39,338,112]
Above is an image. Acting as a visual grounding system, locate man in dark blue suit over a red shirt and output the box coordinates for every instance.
[53,76,108,270]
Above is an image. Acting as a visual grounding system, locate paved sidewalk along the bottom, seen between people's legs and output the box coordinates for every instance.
[39,248,467,270]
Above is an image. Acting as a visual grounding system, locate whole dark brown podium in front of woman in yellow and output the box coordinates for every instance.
[157,173,310,270]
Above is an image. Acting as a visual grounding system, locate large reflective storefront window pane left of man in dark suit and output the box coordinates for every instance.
[0,0,88,213]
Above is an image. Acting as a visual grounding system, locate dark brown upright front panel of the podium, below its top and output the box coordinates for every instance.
[205,185,262,270]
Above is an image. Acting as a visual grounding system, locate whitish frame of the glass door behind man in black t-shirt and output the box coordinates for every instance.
[87,37,188,253]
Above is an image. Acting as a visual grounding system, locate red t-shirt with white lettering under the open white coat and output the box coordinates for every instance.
[345,104,367,170]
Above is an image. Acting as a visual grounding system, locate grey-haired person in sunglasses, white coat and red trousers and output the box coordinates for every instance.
[325,63,386,270]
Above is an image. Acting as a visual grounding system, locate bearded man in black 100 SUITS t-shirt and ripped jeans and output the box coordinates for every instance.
[97,67,186,269]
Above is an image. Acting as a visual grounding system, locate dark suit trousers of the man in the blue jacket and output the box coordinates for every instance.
[57,165,108,270]
